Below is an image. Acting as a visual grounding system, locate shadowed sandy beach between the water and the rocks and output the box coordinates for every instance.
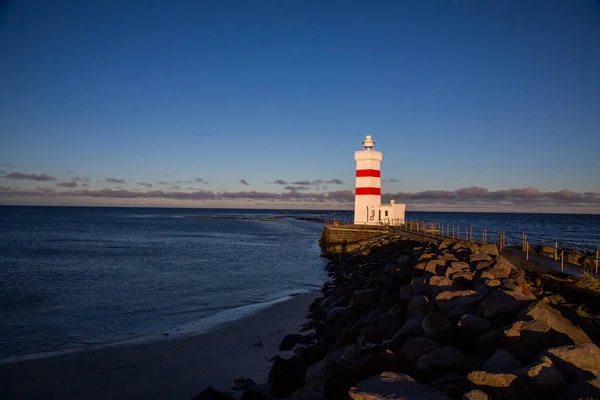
[0,293,318,400]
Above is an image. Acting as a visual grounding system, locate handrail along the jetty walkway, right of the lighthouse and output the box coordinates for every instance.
[398,221,600,275]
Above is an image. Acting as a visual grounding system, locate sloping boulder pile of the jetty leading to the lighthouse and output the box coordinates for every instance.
[197,235,600,400]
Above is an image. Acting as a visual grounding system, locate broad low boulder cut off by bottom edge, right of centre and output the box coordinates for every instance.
[348,372,450,400]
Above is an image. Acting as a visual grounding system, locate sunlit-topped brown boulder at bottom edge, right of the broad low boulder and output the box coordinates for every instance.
[467,371,531,400]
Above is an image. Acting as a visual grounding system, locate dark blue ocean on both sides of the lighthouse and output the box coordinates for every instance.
[0,206,600,362]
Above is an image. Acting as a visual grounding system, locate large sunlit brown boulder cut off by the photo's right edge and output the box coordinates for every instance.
[540,343,600,381]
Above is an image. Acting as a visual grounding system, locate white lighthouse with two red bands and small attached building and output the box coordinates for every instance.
[354,136,406,225]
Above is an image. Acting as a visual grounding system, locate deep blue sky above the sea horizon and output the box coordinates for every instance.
[0,0,600,212]
